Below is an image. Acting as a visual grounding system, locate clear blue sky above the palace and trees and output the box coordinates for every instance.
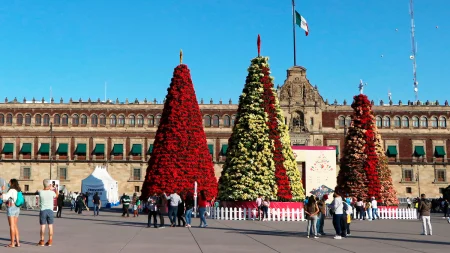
[0,0,450,104]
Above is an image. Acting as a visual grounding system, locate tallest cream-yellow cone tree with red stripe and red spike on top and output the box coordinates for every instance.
[219,36,304,201]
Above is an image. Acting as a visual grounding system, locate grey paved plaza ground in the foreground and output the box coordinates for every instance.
[0,210,450,253]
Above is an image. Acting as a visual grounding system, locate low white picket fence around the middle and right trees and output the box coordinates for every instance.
[209,207,417,221]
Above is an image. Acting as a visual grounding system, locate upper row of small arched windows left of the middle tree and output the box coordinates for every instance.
[0,113,236,127]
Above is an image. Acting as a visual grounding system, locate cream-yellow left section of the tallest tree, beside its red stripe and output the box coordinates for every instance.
[219,58,278,200]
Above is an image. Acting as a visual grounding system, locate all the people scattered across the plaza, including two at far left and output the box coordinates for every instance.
[0,179,450,248]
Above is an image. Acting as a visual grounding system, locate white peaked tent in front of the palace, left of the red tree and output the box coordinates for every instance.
[81,166,119,207]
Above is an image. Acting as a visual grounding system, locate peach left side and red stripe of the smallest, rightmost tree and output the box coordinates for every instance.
[337,94,381,199]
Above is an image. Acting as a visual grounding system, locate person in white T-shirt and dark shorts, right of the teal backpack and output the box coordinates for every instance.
[37,179,58,246]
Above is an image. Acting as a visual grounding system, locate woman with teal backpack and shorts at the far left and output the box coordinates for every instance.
[0,179,24,248]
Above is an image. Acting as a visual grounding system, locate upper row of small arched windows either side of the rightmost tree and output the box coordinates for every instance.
[339,116,447,128]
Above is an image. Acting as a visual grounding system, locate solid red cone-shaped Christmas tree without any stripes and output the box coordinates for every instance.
[142,58,217,198]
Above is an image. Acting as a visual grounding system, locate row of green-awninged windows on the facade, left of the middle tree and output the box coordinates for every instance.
[2,143,228,159]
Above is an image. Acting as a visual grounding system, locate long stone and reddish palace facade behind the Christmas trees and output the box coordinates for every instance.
[0,66,450,198]
